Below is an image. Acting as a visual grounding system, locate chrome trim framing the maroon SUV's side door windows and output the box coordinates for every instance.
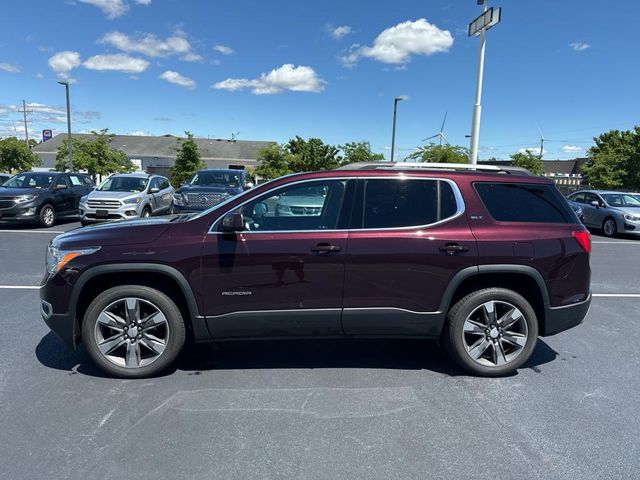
[207,174,466,235]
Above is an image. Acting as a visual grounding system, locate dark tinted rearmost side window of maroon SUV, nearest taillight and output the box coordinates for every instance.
[474,182,578,223]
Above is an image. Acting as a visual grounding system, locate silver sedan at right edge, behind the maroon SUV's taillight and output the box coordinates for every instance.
[568,190,640,237]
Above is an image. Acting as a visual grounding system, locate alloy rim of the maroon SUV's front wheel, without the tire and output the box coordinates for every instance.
[94,297,170,368]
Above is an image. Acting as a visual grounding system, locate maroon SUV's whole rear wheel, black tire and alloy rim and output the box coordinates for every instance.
[442,288,538,377]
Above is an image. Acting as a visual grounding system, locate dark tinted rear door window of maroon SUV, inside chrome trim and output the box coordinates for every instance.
[354,179,458,229]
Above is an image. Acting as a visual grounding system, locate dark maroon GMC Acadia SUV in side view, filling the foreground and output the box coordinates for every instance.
[41,162,591,377]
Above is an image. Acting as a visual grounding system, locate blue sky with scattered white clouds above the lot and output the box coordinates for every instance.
[0,0,640,159]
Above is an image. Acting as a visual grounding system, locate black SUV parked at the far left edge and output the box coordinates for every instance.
[0,172,94,227]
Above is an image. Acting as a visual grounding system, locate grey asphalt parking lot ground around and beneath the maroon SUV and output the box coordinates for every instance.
[0,223,640,479]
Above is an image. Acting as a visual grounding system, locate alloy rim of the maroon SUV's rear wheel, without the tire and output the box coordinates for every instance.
[462,300,529,367]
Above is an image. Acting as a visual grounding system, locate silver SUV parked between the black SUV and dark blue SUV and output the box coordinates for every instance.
[80,173,174,225]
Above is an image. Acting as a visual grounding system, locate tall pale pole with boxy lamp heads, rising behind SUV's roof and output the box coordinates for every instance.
[469,0,502,165]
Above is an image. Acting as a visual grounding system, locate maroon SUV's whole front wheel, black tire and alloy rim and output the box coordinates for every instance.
[82,285,185,378]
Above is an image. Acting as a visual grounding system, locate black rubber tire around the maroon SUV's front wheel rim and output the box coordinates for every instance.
[82,285,185,378]
